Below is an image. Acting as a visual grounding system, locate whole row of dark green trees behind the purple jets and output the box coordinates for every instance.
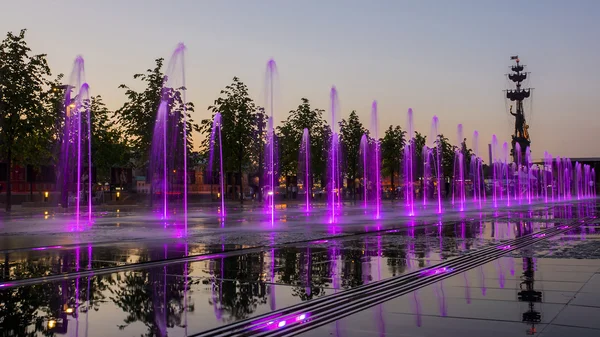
[0,30,474,210]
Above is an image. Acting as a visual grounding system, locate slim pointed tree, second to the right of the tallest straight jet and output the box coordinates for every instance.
[340,110,369,198]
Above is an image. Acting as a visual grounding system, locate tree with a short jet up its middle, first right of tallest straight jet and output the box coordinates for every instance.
[277,98,327,189]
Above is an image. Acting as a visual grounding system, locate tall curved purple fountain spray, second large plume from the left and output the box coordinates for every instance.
[148,43,190,231]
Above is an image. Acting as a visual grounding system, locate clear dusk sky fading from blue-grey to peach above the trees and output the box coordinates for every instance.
[0,0,600,160]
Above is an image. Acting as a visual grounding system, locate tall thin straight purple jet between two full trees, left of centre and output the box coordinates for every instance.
[265,59,279,226]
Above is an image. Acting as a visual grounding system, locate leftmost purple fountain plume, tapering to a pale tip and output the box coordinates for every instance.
[60,56,94,230]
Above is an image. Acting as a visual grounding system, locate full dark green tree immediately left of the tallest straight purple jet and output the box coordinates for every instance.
[201,77,263,203]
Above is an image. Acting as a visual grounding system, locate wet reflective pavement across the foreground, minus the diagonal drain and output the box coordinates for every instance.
[0,203,600,336]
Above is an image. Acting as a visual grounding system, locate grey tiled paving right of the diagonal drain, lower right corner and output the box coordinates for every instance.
[301,258,600,337]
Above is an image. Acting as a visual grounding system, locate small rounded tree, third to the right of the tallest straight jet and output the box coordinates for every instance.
[380,125,406,191]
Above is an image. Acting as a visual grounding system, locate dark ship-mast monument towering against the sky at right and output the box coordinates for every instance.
[506,56,531,162]
